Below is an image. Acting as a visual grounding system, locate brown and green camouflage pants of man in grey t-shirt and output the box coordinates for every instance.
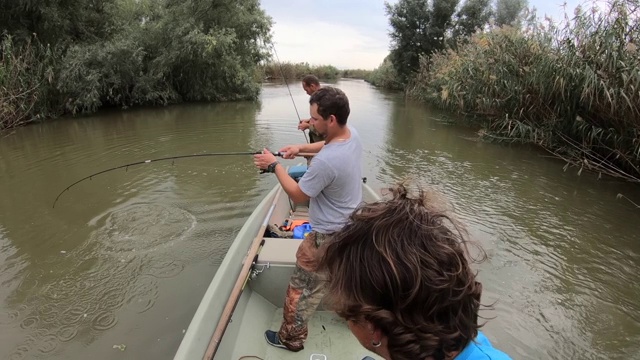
[278,231,329,351]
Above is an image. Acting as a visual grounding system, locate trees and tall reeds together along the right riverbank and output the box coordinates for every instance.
[371,0,640,182]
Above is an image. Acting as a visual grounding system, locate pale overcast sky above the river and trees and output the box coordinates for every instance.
[261,0,608,69]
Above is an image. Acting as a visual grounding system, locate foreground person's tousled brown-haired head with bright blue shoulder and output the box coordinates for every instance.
[322,185,509,360]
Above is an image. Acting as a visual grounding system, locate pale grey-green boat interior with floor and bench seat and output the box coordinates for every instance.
[221,187,376,360]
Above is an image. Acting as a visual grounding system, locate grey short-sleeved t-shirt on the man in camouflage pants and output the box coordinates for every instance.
[298,126,362,234]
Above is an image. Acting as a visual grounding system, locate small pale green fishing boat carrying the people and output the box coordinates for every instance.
[174,166,380,360]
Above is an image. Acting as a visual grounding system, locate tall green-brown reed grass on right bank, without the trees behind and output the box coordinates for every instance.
[407,0,640,182]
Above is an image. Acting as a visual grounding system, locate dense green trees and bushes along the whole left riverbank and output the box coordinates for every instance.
[0,0,272,129]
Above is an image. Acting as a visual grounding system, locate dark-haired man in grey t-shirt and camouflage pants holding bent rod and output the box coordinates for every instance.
[254,87,362,351]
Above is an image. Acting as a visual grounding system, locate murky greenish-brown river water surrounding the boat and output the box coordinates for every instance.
[0,80,640,360]
